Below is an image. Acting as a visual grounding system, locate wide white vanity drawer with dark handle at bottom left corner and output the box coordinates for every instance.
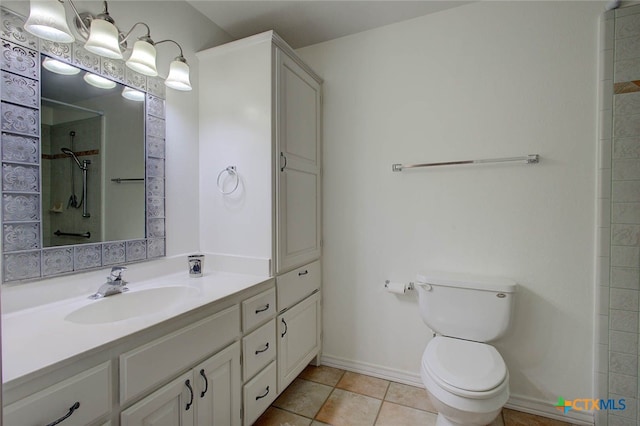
[4,362,111,426]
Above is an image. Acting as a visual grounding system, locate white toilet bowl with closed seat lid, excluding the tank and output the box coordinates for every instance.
[420,336,509,426]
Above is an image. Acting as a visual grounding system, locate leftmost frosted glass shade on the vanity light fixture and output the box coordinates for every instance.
[24,0,75,43]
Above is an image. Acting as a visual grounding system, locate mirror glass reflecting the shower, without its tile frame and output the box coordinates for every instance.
[40,55,145,247]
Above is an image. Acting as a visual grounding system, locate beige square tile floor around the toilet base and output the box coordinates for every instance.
[254,365,569,426]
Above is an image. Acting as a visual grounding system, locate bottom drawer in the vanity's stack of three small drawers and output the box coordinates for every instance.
[242,361,277,426]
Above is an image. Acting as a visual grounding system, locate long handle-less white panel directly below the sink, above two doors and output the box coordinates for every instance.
[120,305,240,403]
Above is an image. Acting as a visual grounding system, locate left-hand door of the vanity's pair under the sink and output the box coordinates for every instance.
[120,371,196,426]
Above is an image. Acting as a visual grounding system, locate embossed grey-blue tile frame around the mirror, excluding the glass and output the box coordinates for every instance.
[0,7,166,283]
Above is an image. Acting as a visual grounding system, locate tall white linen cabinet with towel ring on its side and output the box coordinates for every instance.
[198,31,322,424]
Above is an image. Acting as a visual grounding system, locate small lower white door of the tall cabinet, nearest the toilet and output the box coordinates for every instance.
[278,293,320,392]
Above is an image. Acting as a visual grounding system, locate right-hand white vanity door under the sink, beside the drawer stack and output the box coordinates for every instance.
[193,342,241,426]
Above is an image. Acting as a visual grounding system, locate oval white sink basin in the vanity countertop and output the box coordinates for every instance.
[65,286,198,324]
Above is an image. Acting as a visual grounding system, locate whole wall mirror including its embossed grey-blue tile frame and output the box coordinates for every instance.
[0,7,166,283]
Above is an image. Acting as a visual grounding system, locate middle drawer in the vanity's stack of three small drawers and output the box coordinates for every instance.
[242,318,276,381]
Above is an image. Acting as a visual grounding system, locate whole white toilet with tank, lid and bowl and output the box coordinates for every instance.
[415,273,516,426]
